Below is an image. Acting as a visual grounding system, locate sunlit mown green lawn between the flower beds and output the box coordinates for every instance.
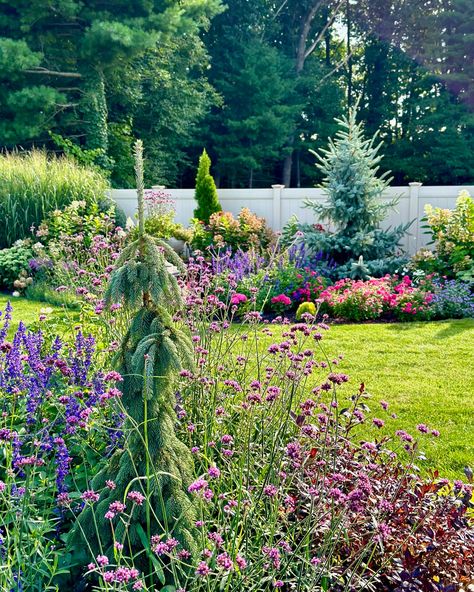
[0,296,474,478]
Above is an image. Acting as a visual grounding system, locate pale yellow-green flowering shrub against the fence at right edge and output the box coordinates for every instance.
[413,190,474,281]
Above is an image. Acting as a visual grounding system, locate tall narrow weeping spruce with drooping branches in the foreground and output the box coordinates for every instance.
[70,141,196,570]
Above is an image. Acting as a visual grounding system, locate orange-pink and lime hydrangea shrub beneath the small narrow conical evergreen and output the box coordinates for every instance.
[192,208,275,251]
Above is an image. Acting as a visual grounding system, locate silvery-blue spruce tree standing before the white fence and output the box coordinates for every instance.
[301,109,409,277]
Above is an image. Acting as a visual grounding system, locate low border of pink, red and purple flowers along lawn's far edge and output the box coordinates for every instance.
[191,244,474,322]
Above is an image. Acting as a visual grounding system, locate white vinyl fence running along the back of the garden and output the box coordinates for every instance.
[112,183,474,254]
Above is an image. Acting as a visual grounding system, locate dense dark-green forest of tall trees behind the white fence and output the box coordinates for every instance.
[0,0,474,187]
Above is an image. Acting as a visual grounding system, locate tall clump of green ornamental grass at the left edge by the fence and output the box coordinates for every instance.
[0,150,108,247]
